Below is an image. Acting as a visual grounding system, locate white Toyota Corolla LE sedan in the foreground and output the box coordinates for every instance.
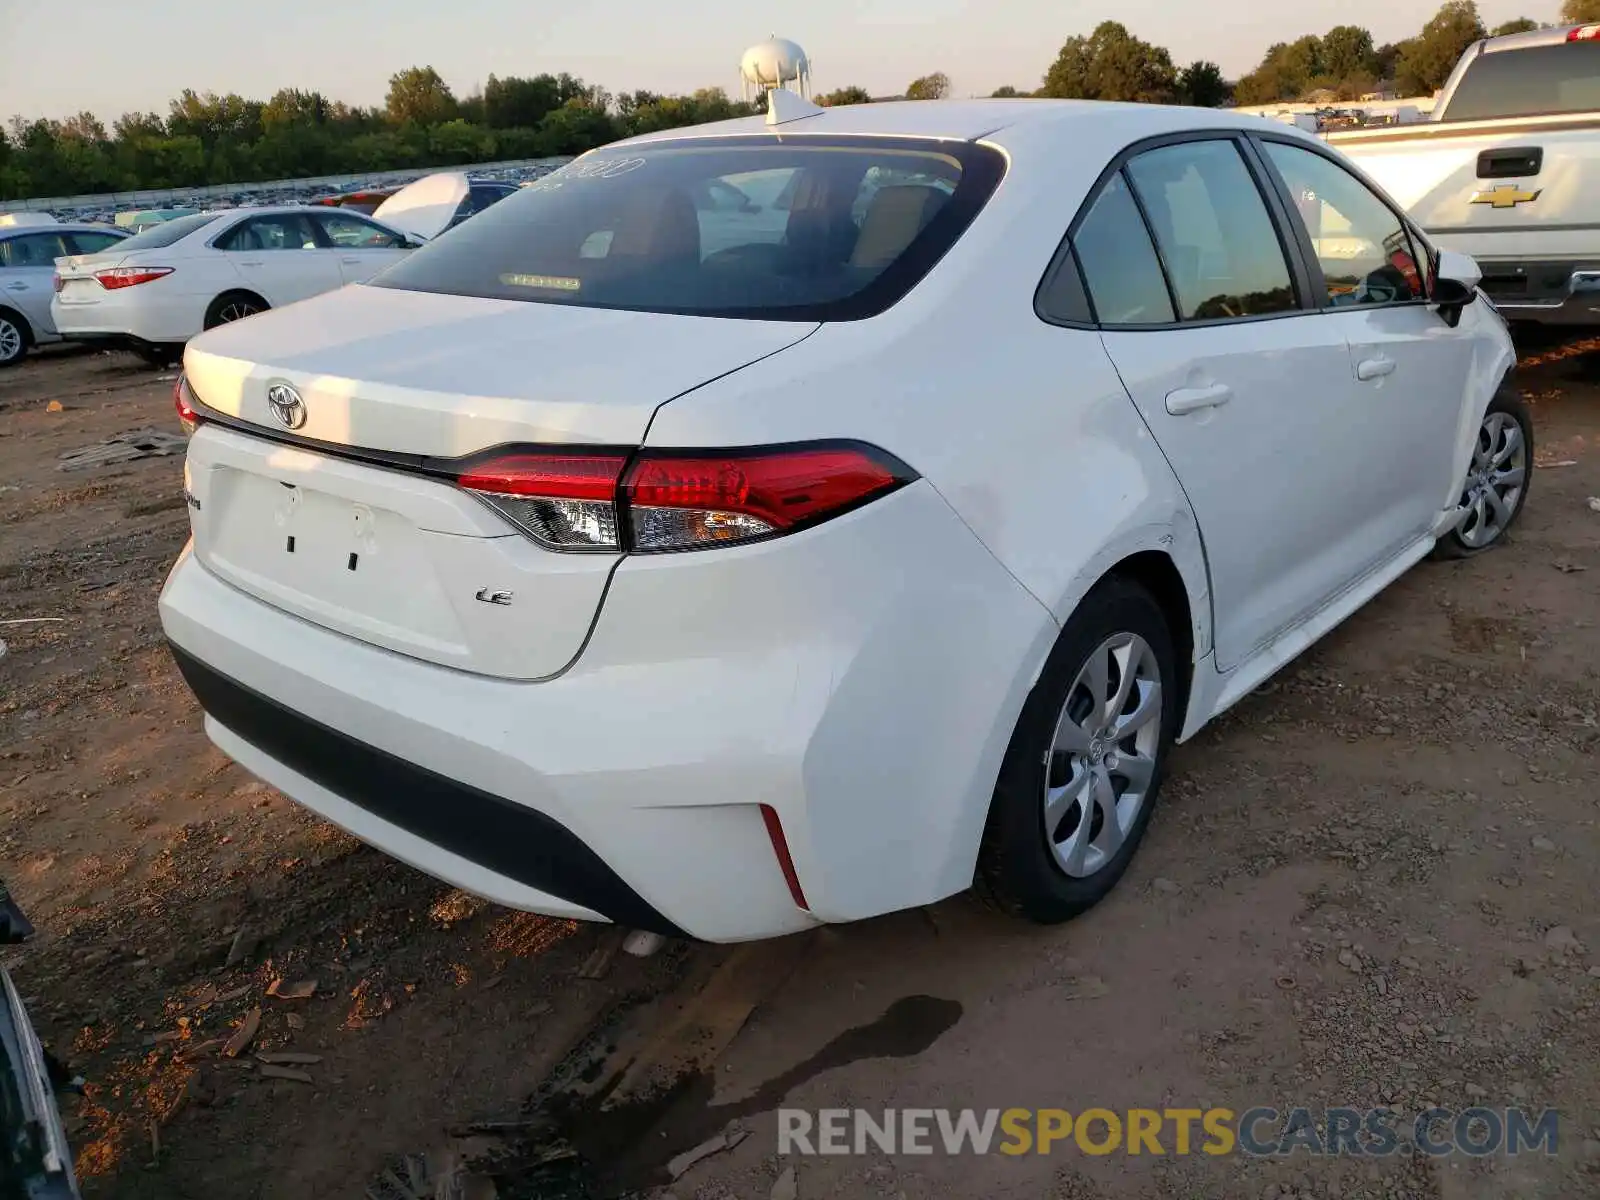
[160,101,1533,941]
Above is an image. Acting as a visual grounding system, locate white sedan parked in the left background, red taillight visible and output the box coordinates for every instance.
[50,205,418,362]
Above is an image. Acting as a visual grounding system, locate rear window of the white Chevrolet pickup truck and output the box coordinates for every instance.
[1440,42,1600,122]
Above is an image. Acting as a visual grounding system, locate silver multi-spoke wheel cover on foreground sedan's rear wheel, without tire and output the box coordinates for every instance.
[1043,634,1162,878]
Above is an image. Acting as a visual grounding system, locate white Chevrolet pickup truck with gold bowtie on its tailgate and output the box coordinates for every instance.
[1326,26,1600,325]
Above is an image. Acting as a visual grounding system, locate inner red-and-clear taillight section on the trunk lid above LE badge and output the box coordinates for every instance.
[456,454,627,550]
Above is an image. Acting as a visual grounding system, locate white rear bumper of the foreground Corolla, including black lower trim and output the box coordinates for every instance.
[160,483,1056,941]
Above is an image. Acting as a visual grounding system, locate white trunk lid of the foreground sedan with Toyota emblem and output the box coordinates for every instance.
[184,286,816,680]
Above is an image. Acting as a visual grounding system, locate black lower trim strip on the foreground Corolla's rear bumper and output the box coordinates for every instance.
[171,645,685,938]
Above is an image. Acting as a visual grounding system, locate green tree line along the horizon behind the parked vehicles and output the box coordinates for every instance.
[0,0,1600,200]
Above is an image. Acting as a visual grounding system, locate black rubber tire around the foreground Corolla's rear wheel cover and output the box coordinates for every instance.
[976,578,1182,925]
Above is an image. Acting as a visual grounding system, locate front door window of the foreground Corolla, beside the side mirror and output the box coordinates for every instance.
[1262,141,1427,307]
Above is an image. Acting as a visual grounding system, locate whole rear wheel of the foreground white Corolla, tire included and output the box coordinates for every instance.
[978,579,1179,923]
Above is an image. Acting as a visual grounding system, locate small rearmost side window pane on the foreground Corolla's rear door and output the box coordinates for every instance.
[1061,171,1173,325]
